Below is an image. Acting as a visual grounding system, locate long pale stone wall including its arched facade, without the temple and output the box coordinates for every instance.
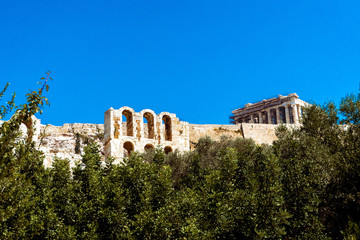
[7,107,298,167]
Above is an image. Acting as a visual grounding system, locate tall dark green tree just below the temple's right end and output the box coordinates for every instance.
[274,108,338,239]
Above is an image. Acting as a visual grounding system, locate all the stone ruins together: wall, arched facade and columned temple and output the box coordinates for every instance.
[9,93,307,167]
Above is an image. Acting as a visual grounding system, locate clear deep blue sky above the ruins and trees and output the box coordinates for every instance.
[0,0,360,125]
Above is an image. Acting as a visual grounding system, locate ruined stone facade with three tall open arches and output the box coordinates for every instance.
[104,107,190,161]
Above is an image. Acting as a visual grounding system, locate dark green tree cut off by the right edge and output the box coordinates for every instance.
[324,94,360,239]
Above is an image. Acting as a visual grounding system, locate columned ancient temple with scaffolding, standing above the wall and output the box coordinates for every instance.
[230,93,308,124]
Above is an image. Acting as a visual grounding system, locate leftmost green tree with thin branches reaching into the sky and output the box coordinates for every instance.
[0,73,51,239]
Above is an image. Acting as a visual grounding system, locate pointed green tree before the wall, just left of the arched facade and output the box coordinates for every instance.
[68,143,128,239]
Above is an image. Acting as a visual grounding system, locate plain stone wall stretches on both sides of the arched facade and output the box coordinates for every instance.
[38,123,286,167]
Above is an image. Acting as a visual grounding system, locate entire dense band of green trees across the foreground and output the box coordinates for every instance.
[0,78,360,239]
